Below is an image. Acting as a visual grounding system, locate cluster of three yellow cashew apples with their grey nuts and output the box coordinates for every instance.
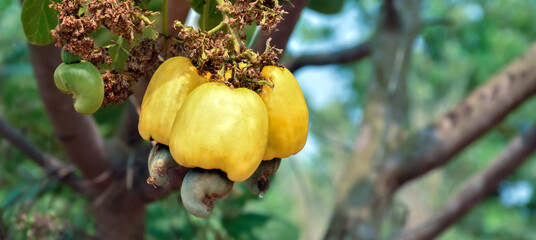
[138,57,309,217]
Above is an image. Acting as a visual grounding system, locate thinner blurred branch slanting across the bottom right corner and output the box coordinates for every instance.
[398,126,536,240]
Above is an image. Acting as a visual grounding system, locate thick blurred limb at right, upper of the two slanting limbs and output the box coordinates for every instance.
[387,42,536,188]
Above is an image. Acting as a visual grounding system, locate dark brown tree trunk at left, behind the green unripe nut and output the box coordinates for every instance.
[29,42,150,240]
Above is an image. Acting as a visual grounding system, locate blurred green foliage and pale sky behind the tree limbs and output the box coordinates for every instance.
[0,0,536,240]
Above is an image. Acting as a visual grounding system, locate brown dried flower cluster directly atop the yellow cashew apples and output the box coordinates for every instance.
[171,0,286,91]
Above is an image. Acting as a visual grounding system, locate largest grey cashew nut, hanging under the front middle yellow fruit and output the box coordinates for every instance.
[181,168,233,218]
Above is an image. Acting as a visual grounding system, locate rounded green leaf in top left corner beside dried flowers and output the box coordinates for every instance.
[21,0,58,45]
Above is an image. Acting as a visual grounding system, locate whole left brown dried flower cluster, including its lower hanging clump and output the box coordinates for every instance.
[50,0,159,106]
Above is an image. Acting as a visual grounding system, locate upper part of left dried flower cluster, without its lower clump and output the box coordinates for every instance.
[49,0,154,65]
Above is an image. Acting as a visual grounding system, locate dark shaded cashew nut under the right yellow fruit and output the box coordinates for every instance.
[244,158,281,198]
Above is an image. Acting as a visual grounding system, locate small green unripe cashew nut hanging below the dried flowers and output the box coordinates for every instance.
[54,61,104,114]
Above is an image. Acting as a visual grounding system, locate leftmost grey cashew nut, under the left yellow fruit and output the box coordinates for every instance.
[147,143,179,186]
